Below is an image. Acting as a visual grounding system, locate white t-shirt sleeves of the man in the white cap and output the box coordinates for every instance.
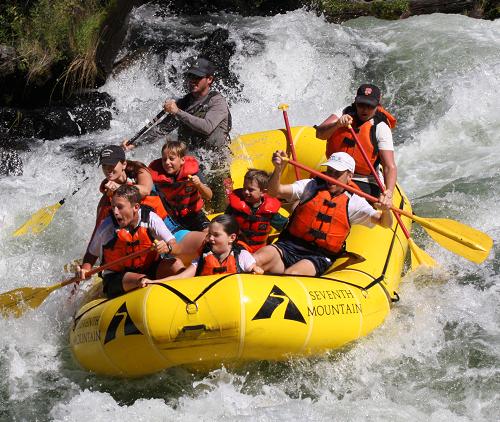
[292,179,378,227]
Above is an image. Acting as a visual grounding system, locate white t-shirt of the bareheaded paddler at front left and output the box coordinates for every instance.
[88,209,174,258]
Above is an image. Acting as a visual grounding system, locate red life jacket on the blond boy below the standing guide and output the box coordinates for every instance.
[149,155,204,217]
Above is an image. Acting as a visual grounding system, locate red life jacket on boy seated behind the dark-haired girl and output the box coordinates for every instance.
[229,189,281,253]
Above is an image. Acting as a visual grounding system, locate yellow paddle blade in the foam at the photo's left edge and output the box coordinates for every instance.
[0,283,62,318]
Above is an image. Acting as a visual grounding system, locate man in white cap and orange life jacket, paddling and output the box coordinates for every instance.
[254,151,392,276]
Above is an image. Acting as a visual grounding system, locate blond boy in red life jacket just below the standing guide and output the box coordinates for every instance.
[149,140,212,231]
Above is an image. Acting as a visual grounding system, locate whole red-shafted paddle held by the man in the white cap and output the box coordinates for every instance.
[284,157,493,264]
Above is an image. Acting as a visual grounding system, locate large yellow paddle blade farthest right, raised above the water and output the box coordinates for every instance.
[420,217,493,264]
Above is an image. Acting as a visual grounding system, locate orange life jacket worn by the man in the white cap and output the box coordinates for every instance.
[286,189,351,254]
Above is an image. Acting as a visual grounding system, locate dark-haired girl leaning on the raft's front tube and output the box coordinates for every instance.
[155,214,263,281]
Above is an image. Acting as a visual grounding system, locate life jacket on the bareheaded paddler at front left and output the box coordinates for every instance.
[102,206,159,273]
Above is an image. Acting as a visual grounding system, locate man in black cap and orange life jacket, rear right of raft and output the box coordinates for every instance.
[316,84,397,206]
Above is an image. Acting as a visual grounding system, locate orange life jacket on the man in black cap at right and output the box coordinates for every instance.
[326,105,396,175]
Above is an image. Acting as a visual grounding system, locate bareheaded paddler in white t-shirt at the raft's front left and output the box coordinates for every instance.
[77,185,185,298]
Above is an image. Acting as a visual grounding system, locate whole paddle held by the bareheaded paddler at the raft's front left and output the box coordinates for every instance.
[0,248,151,318]
